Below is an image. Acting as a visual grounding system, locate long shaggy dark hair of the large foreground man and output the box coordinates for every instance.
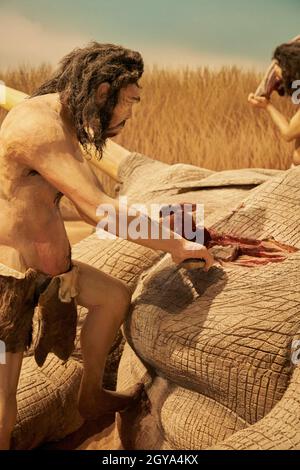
[31,42,144,158]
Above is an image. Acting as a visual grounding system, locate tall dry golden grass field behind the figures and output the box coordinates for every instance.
[0,64,295,178]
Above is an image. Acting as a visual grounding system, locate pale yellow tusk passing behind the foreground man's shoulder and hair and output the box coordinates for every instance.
[0,82,131,181]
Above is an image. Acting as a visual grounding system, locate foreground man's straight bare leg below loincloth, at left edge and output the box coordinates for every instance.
[0,352,23,450]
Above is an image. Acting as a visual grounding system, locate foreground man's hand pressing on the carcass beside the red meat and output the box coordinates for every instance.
[171,239,215,272]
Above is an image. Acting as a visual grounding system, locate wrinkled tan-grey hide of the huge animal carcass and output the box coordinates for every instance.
[14,154,300,449]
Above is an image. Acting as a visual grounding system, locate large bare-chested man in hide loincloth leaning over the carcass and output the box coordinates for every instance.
[0,43,213,449]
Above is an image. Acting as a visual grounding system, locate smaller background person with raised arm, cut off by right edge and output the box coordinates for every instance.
[248,37,300,166]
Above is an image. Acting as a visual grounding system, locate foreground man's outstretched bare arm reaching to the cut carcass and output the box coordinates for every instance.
[10,123,214,270]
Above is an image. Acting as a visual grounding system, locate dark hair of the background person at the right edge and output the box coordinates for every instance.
[273,42,300,95]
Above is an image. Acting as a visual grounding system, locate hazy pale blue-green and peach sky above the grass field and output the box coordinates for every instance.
[0,0,300,68]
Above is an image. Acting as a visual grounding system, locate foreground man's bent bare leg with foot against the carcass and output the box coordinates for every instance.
[74,261,141,419]
